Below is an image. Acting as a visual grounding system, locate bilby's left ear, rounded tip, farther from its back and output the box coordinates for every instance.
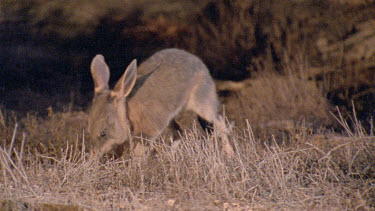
[91,54,109,93]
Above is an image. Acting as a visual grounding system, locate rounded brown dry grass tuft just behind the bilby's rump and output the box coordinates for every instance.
[224,53,337,143]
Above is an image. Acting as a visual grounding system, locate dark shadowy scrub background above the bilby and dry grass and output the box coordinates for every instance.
[0,0,375,127]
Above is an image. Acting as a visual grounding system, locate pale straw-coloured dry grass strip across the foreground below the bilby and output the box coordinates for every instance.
[0,105,375,210]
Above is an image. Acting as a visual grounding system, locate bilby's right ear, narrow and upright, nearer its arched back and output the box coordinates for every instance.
[111,59,137,97]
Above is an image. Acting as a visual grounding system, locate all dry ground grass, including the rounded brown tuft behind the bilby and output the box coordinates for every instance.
[0,47,375,210]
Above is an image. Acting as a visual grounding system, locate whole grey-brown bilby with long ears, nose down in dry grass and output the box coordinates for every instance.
[88,49,233,156]
